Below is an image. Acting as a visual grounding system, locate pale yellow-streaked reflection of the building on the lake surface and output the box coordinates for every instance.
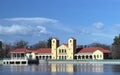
[4,64,106,72]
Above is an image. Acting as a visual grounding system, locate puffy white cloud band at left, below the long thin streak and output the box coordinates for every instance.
[0,25,49,36]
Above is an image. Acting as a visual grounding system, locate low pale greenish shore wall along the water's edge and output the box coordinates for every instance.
[0,59,120,65]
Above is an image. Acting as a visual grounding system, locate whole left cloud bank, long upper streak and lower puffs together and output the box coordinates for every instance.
[0,17,75,36]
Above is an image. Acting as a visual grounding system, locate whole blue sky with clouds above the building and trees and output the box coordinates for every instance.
[0,0,120,45]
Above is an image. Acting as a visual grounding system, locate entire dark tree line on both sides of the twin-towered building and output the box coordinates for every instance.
[0,35,120,59]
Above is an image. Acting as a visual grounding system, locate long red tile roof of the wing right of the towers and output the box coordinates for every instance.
[79,47,110,53]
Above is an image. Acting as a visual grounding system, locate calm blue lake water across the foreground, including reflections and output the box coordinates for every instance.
[0,64,120,75]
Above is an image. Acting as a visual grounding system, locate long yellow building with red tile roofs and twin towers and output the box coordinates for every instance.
[10,38,110,60]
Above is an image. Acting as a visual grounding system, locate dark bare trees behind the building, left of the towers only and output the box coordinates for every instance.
[0,38,52,58]
